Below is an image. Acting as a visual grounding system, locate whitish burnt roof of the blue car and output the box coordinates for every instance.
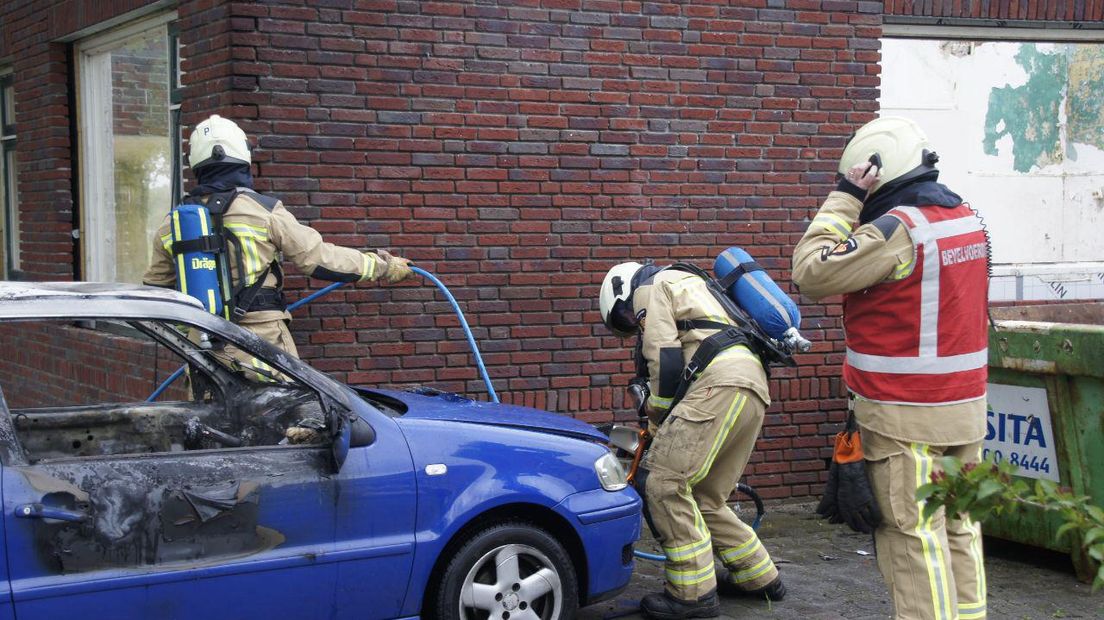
[0,281,203,308]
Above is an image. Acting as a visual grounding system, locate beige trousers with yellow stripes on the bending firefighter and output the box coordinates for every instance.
[645,386,778,600]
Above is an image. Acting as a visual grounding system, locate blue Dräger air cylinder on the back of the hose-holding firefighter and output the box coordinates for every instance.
[171,204,223,316]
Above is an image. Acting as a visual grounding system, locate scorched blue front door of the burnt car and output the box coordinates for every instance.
[0,317,414,620]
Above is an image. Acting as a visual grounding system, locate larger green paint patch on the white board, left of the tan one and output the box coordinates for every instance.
[983,43,1068,172]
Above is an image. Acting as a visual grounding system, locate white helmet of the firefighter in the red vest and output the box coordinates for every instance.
[839,116,940,194]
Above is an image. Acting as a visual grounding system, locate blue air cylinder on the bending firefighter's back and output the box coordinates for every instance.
[713,247,802,341]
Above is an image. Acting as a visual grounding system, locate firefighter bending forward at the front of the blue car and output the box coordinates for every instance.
[599,263,786,618]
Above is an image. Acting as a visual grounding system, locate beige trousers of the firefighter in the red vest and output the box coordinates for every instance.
[861,428,986,620]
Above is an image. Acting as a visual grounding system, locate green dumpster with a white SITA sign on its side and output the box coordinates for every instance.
[984,302,1104,580]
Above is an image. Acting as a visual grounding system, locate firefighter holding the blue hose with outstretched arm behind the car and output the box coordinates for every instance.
[142,115,412,374]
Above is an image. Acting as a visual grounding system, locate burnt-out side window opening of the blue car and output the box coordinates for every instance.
[0,319,327,463]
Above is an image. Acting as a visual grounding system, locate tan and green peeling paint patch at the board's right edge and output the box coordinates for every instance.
[1066,45,1104,151]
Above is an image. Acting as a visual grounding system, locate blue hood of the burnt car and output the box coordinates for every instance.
[360,389,608,443]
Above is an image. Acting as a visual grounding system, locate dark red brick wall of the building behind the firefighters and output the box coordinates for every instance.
[0,0,1095,496]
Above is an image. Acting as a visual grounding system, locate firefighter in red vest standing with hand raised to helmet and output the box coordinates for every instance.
[793,117,989,620]
